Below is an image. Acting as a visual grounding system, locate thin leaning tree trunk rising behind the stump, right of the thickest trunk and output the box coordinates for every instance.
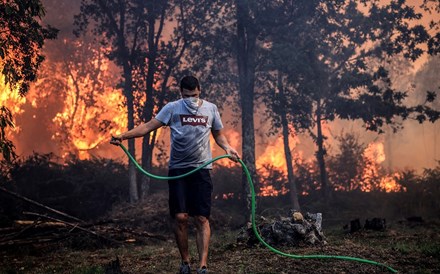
[278,72,301,211]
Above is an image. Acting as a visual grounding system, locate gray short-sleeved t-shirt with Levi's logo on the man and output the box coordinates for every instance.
[156,99,223,169]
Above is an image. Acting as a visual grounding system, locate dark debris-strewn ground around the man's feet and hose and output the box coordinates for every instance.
[0,194,440,274]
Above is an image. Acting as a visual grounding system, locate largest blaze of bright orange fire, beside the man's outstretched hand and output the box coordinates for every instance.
[42,43,127,159]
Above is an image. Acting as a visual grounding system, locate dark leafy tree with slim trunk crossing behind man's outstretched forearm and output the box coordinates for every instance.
[75,1,151,202]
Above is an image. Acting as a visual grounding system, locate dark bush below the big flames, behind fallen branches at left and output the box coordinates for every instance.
[1,154,128,220]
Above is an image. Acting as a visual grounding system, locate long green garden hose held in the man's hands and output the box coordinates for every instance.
[120,144,397,273]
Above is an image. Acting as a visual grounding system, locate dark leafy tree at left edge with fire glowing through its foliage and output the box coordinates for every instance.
[0,0,57,161]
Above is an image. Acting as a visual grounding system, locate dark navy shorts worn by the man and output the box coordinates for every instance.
[168,167,212,218]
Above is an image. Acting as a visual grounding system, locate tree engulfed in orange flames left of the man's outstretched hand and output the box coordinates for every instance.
[35,37,127,159]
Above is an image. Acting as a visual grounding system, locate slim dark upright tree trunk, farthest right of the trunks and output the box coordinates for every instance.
[316,100,329,199]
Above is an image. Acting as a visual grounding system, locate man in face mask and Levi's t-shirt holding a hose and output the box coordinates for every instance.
[111,76,239,274]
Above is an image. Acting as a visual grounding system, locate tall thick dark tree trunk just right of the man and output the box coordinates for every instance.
[236,0,258,223]
